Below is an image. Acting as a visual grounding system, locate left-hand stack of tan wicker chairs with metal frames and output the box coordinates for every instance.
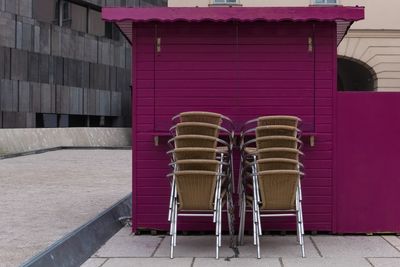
[168,112,234,259]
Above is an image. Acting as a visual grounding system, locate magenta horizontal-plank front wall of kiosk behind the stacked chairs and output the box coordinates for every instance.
[133,22,336,231]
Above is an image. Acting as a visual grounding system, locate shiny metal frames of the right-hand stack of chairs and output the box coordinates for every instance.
[238,116,305,258]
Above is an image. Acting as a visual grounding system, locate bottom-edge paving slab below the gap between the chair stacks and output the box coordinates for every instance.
[193,258,281,267]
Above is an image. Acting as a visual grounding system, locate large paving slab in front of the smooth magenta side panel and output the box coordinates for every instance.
[312,236,400,258]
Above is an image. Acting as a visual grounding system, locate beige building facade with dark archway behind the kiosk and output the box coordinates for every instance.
[168,0,400,91]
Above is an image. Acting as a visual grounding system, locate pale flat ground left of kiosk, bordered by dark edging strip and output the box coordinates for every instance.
[0,149,132,267]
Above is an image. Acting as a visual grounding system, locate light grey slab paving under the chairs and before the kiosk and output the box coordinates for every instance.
[82,227,400,267]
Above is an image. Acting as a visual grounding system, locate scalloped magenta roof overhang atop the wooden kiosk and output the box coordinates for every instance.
[102,6,364,44]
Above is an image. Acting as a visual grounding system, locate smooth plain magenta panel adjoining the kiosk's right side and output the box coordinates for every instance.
[336,92,400,233]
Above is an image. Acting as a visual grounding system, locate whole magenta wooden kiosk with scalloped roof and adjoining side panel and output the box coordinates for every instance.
[103,7,400,232]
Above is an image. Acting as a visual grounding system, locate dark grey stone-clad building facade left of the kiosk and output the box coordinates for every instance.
[0,0,166,128]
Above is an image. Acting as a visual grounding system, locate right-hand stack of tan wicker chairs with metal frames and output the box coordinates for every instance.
[239,116,305,258]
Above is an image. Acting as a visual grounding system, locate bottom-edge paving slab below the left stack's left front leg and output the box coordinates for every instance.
[101,258,193,267]
